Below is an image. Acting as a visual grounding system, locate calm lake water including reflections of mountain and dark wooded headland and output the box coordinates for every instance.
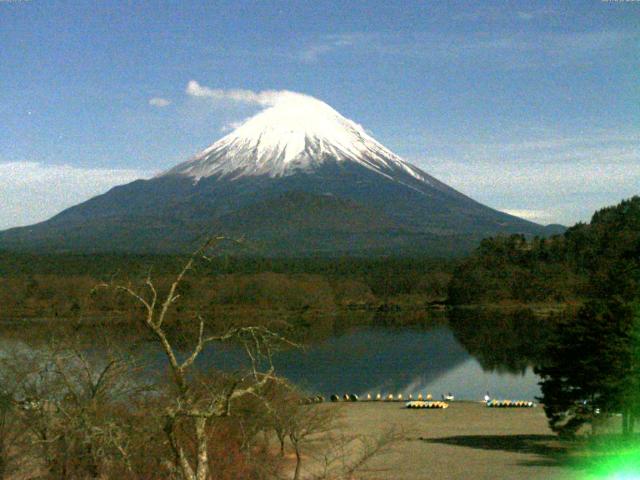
[0,311,546,400]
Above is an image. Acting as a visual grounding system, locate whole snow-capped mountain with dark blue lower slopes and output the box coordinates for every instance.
[0,92,556,255]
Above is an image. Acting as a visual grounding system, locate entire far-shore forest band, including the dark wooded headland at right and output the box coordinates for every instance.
[5,197,640,319]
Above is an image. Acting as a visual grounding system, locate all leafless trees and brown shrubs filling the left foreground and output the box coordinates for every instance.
[0,245,400,480]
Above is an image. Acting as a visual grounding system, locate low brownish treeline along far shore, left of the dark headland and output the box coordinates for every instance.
[0,253,454,319]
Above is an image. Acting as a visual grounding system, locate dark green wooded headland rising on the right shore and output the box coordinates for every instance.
[448,197,640,305]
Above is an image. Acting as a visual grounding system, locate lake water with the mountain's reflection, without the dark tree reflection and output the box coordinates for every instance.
[196,326,540,400]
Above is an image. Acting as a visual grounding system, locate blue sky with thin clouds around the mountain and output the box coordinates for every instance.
[0,0,640,228]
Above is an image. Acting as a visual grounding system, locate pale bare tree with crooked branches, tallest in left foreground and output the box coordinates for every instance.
[99,237,294,480]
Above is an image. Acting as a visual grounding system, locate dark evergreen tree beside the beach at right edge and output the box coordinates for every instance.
[536,300,640,436]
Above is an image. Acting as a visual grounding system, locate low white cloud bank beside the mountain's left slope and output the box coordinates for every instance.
[0,162,145,229]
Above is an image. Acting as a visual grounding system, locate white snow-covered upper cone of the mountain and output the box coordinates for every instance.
[163,92,426,181]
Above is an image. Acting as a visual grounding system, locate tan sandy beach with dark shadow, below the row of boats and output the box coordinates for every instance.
[328,402,576,480]
